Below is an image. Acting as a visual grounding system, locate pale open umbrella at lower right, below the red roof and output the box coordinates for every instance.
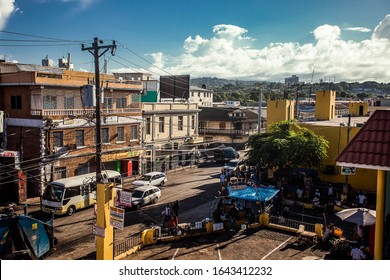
[336,208,376,226]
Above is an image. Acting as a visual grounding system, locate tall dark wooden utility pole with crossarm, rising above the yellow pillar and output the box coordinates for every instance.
[81,37,116,182]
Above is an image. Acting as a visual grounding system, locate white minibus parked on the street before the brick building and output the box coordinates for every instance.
[42,170,122,216]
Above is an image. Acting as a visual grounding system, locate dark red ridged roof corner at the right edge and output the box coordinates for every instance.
[336,110,390,170]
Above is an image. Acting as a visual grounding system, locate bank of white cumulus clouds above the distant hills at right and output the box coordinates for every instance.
[153,15,390,82]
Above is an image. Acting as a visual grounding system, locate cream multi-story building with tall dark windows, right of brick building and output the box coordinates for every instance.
[142,102,203,172]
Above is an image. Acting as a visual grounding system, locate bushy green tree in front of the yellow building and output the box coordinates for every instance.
[247,121,329,169]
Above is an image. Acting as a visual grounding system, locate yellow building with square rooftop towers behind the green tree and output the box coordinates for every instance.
[267,91,377,192]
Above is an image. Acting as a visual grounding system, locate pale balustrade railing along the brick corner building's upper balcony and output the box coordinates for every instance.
[31,107,141,117]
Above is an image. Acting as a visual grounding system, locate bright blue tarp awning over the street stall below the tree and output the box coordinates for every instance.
[228,185,279,202]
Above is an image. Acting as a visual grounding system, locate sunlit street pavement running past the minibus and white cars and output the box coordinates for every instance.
[46,166,221,260]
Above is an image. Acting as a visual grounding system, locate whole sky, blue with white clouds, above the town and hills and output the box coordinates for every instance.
[0,0,390,82]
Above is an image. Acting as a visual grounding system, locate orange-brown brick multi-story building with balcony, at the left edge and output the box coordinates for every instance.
[0,62,143,201]
